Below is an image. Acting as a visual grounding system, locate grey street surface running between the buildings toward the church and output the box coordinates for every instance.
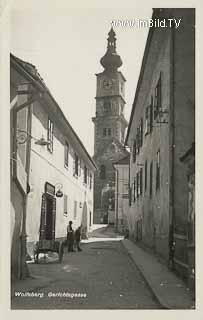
[12,226,160,309]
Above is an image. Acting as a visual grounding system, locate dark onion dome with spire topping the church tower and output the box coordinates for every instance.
[100,28,123,70]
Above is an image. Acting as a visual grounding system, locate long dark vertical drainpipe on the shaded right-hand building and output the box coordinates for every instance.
[169,25,175,269]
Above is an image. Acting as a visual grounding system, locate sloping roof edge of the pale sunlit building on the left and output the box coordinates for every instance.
[10,54,97,170]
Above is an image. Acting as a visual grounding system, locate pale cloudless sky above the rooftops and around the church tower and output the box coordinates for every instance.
[10,0,152,156]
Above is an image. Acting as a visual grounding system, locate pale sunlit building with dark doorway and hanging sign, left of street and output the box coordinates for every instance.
[11,56,96,272]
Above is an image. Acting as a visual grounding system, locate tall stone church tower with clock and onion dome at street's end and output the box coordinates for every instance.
[92,28,128,223]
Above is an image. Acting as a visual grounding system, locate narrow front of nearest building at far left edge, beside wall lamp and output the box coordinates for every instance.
[10,55,34,279]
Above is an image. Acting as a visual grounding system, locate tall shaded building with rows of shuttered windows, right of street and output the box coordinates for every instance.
[126,9,195,275]
